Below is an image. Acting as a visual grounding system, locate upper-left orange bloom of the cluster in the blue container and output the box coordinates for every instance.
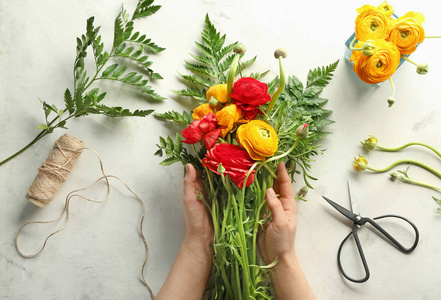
[355,5,390,41]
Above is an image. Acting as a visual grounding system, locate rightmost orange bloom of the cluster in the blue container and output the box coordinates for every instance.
[387,11,425,55]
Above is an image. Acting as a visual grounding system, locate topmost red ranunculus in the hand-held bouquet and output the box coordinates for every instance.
[230,77,271,120]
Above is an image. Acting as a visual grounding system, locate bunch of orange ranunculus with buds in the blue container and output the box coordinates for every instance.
[346,1,435,107]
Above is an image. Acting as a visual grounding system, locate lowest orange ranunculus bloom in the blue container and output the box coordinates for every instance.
[349,40,401,84]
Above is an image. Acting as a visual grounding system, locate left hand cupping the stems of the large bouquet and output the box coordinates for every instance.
[184,164,214,246]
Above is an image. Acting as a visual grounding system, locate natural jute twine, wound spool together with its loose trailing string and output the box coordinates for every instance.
[15,135,155,299]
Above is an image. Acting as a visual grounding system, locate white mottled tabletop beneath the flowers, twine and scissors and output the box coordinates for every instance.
[0,0,441,299]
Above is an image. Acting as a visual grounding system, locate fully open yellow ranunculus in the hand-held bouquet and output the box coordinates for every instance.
[236,120,279,160]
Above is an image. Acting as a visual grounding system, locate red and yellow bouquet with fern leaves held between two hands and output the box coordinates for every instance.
[156,16,338,299]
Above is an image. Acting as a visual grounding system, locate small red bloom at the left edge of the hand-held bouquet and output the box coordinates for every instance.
[182,113,221,150]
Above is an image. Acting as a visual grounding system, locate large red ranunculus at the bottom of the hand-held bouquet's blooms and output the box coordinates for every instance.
[202,143,256,188]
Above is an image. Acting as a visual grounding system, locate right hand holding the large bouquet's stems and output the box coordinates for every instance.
[258,163,297,264]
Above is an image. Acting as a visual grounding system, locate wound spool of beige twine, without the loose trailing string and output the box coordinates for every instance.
[26,134,84,207]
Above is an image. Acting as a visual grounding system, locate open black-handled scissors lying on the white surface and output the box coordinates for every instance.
[323,180,419,282]
